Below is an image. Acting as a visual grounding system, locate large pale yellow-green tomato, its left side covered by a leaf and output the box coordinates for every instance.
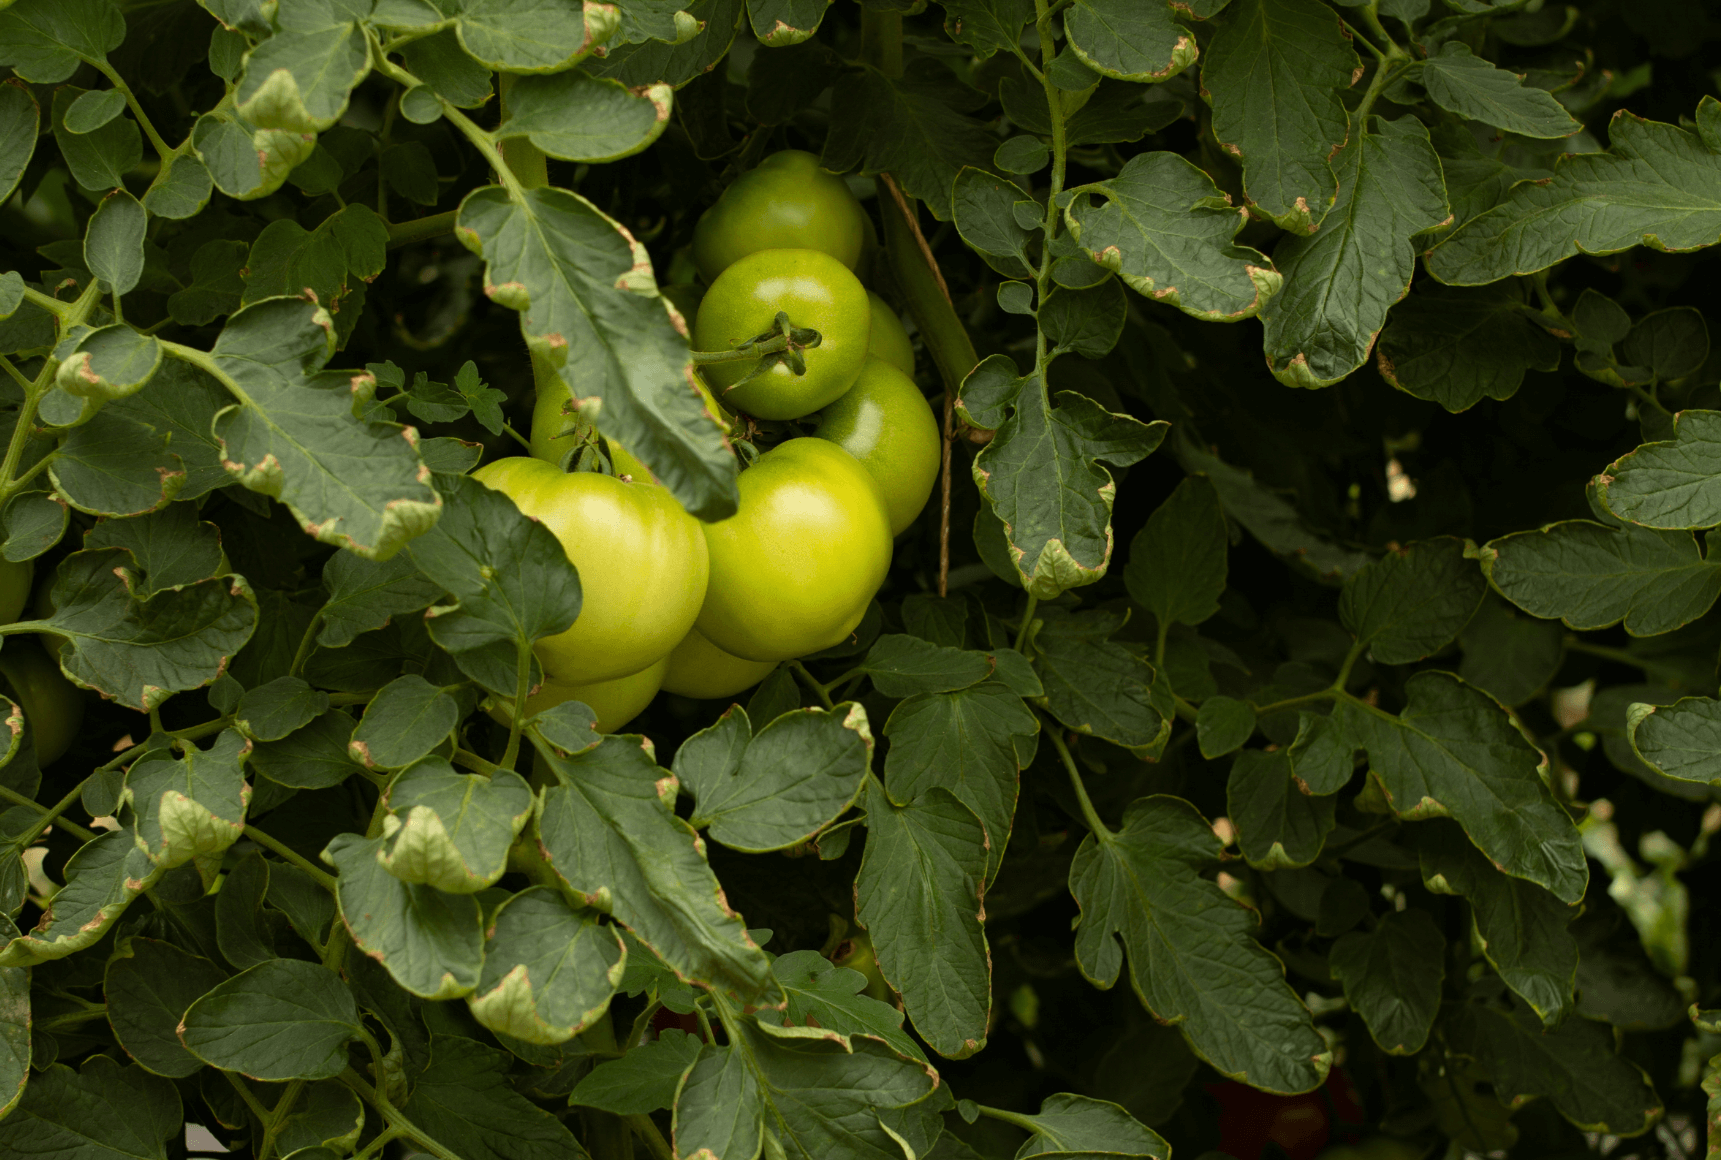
[472,456,706,683]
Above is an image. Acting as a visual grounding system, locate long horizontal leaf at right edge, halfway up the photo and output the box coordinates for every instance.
[1477,520,1722,637]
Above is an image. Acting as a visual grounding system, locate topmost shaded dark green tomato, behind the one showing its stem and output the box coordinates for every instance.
[694,150,870,284]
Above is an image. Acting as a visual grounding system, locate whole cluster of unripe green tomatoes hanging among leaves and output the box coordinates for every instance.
[474,150,940,731]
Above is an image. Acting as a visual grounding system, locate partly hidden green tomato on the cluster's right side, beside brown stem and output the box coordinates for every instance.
[813,356,940,535]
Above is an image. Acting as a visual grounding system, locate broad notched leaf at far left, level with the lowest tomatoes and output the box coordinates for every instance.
[34,547,257,713]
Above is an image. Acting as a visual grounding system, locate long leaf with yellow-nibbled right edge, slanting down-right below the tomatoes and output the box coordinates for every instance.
[530,730,780,1007]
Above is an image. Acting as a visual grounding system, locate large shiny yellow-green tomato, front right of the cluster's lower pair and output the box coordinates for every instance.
[697,439,890,661]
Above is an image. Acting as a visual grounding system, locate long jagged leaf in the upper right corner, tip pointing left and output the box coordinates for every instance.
[1428,96,1722,286]
